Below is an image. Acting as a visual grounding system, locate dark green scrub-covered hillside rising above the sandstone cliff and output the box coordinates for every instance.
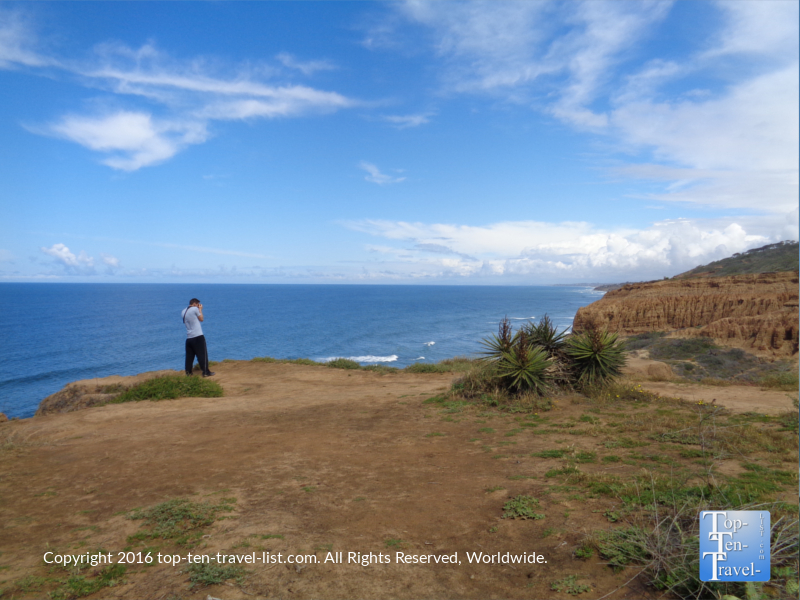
[673,241,800,279]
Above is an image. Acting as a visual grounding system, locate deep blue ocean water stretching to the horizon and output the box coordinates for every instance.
[0,283,602,417]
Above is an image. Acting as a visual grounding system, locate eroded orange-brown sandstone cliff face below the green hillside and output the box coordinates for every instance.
[573,273,798,357]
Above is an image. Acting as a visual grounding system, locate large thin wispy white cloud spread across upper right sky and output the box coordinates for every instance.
[384,0,800,212]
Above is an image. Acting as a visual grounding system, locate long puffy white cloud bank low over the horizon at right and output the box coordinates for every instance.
[345,211,798,282]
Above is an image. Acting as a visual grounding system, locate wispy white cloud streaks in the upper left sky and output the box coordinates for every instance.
[0,11,359,171]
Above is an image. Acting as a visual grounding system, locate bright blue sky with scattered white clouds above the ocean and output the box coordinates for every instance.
[0,0,800,285]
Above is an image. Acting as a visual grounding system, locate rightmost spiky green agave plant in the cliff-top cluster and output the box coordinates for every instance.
[565,329,625,385]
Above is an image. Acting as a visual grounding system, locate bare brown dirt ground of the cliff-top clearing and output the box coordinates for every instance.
[0,362,791,600]
